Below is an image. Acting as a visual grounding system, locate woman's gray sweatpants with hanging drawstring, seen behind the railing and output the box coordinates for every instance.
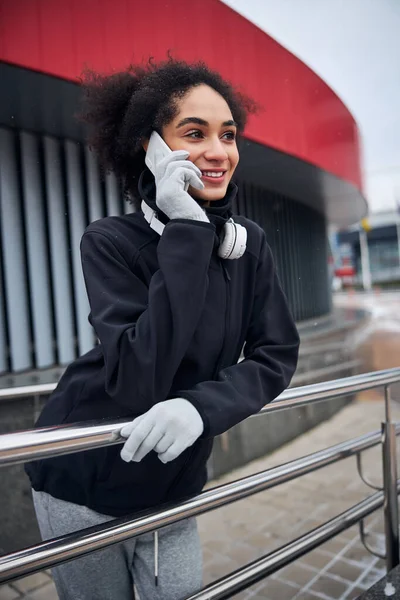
[33,490,202,600]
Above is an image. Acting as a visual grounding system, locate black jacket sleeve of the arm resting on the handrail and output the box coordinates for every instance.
[177,238,299,437]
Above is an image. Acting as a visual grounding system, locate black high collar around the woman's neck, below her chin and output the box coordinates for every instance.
[138,168,238,233]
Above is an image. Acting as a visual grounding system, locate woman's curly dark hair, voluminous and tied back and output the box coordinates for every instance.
[78,57,257,207]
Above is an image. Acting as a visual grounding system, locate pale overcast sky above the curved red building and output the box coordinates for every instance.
[224,0,400,212]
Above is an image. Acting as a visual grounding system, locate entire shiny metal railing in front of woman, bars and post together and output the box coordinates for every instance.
[0,368,400,588]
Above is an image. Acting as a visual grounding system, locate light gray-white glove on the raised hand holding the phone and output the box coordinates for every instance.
[154,150,209,222]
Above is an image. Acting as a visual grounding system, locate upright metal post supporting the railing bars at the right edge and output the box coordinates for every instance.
[382,385,400,572]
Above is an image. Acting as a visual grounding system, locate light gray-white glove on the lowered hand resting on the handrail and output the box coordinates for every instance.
[120,398,204,463]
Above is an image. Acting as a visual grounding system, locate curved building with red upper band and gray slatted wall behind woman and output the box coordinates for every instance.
[0,0,366,386]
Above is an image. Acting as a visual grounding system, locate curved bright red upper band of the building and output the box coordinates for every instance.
[0,0,362,190]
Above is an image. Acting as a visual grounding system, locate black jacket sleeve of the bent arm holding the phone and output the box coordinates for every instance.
[81,220,215,414]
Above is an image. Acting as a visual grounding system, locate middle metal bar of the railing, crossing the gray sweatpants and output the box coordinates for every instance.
[0,432,390,583]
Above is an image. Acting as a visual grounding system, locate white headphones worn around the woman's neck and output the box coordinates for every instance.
[141,200,247,260]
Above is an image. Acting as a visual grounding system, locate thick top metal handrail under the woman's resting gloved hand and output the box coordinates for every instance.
[0,368,400,467]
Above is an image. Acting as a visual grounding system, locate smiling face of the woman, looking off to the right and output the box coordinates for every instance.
[161,84,239,202]
